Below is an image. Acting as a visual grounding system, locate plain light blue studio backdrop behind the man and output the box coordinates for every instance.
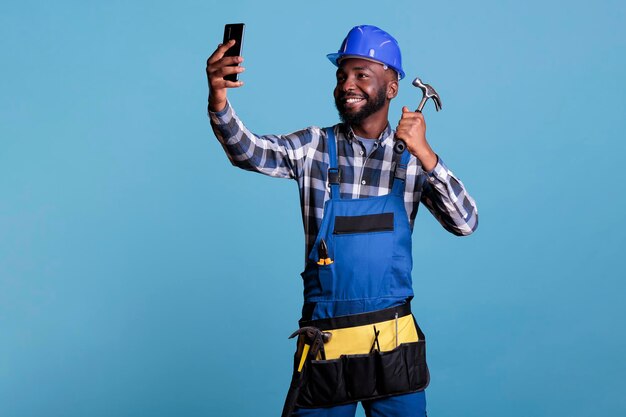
[0,0,626,417]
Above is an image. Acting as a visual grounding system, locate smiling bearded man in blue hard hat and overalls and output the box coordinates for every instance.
[206,25,478,417]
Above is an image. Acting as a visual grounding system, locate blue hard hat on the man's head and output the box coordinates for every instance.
[326,25,404,79]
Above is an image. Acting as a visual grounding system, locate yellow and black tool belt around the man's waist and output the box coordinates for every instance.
[294,304,429,408]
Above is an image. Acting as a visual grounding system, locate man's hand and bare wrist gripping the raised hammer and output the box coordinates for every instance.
[396,106,437,171]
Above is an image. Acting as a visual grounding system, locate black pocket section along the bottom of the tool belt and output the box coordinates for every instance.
[296,340,430,408]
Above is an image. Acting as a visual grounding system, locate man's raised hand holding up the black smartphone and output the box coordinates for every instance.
[206,39,245,112]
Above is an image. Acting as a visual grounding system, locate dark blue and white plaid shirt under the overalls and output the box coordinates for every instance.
[209,103,478,256]
